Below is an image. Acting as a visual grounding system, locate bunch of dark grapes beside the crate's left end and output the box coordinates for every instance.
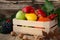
[1,21,12,34]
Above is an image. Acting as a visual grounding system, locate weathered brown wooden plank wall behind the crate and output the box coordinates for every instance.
[0,0,60,17]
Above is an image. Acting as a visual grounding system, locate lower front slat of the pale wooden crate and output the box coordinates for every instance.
[13,26,43,36]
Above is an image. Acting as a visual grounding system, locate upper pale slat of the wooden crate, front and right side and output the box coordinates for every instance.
[13,19,57,28]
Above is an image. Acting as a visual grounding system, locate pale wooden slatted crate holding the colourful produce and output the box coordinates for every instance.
[13,19,57,36]
